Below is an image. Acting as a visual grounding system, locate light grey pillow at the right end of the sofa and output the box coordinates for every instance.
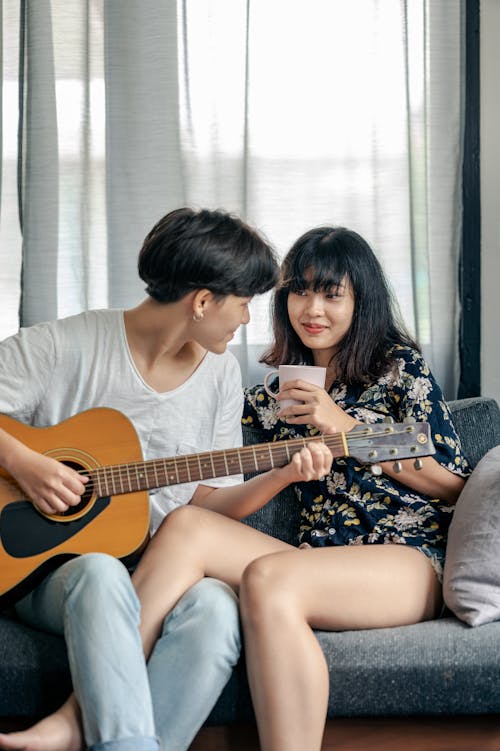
[443,446,500,626]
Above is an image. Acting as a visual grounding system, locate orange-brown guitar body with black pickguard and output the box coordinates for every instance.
[0,407,149,605]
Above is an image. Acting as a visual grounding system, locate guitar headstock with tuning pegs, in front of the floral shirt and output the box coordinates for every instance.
[345,422,436,471]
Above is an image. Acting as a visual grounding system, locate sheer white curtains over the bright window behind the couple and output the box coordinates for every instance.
[0,0,463,398]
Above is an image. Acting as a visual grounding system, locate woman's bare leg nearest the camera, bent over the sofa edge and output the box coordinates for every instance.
[240,545,441,751]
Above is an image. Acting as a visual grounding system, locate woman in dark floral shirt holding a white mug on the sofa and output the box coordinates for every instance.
[124,227,468,751]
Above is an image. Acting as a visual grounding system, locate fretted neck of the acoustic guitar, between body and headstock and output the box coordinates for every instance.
[89,433,349,497]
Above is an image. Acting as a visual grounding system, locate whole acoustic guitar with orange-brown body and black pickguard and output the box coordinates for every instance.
[0,407,435,605]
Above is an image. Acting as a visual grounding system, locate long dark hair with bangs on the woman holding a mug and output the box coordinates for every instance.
[260,227,419,384]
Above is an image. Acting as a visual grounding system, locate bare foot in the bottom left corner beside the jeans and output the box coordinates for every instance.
[0,694,84,751]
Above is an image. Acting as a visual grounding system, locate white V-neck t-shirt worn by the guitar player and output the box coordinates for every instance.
[0,310,243,533]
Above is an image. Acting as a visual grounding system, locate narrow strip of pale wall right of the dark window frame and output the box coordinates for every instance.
[480,0,500,403]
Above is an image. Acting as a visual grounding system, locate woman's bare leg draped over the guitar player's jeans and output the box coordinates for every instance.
[132,505,294,656]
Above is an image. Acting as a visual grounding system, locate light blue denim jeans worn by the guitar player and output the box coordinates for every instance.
[17,553,241,751]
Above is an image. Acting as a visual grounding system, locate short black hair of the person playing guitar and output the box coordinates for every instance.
[138,207,278,303]
